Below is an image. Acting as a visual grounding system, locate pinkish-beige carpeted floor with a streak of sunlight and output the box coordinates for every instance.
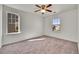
[0,36,78,54]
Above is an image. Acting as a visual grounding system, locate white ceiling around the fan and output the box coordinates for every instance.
[6,4,77,16]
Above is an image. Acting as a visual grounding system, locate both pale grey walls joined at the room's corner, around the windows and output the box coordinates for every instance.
[2,6,78,45]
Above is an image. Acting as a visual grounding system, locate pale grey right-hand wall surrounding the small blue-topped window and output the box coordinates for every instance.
[44,9,78,42]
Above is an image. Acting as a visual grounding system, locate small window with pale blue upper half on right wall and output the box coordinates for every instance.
[52,17,60,31]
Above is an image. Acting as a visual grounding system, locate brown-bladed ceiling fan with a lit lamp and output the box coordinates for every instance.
[35,4,52,14]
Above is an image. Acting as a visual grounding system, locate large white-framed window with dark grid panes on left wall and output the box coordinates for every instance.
[7,13,20,34]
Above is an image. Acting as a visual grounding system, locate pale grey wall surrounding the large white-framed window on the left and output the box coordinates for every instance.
[2,6,43,45]
